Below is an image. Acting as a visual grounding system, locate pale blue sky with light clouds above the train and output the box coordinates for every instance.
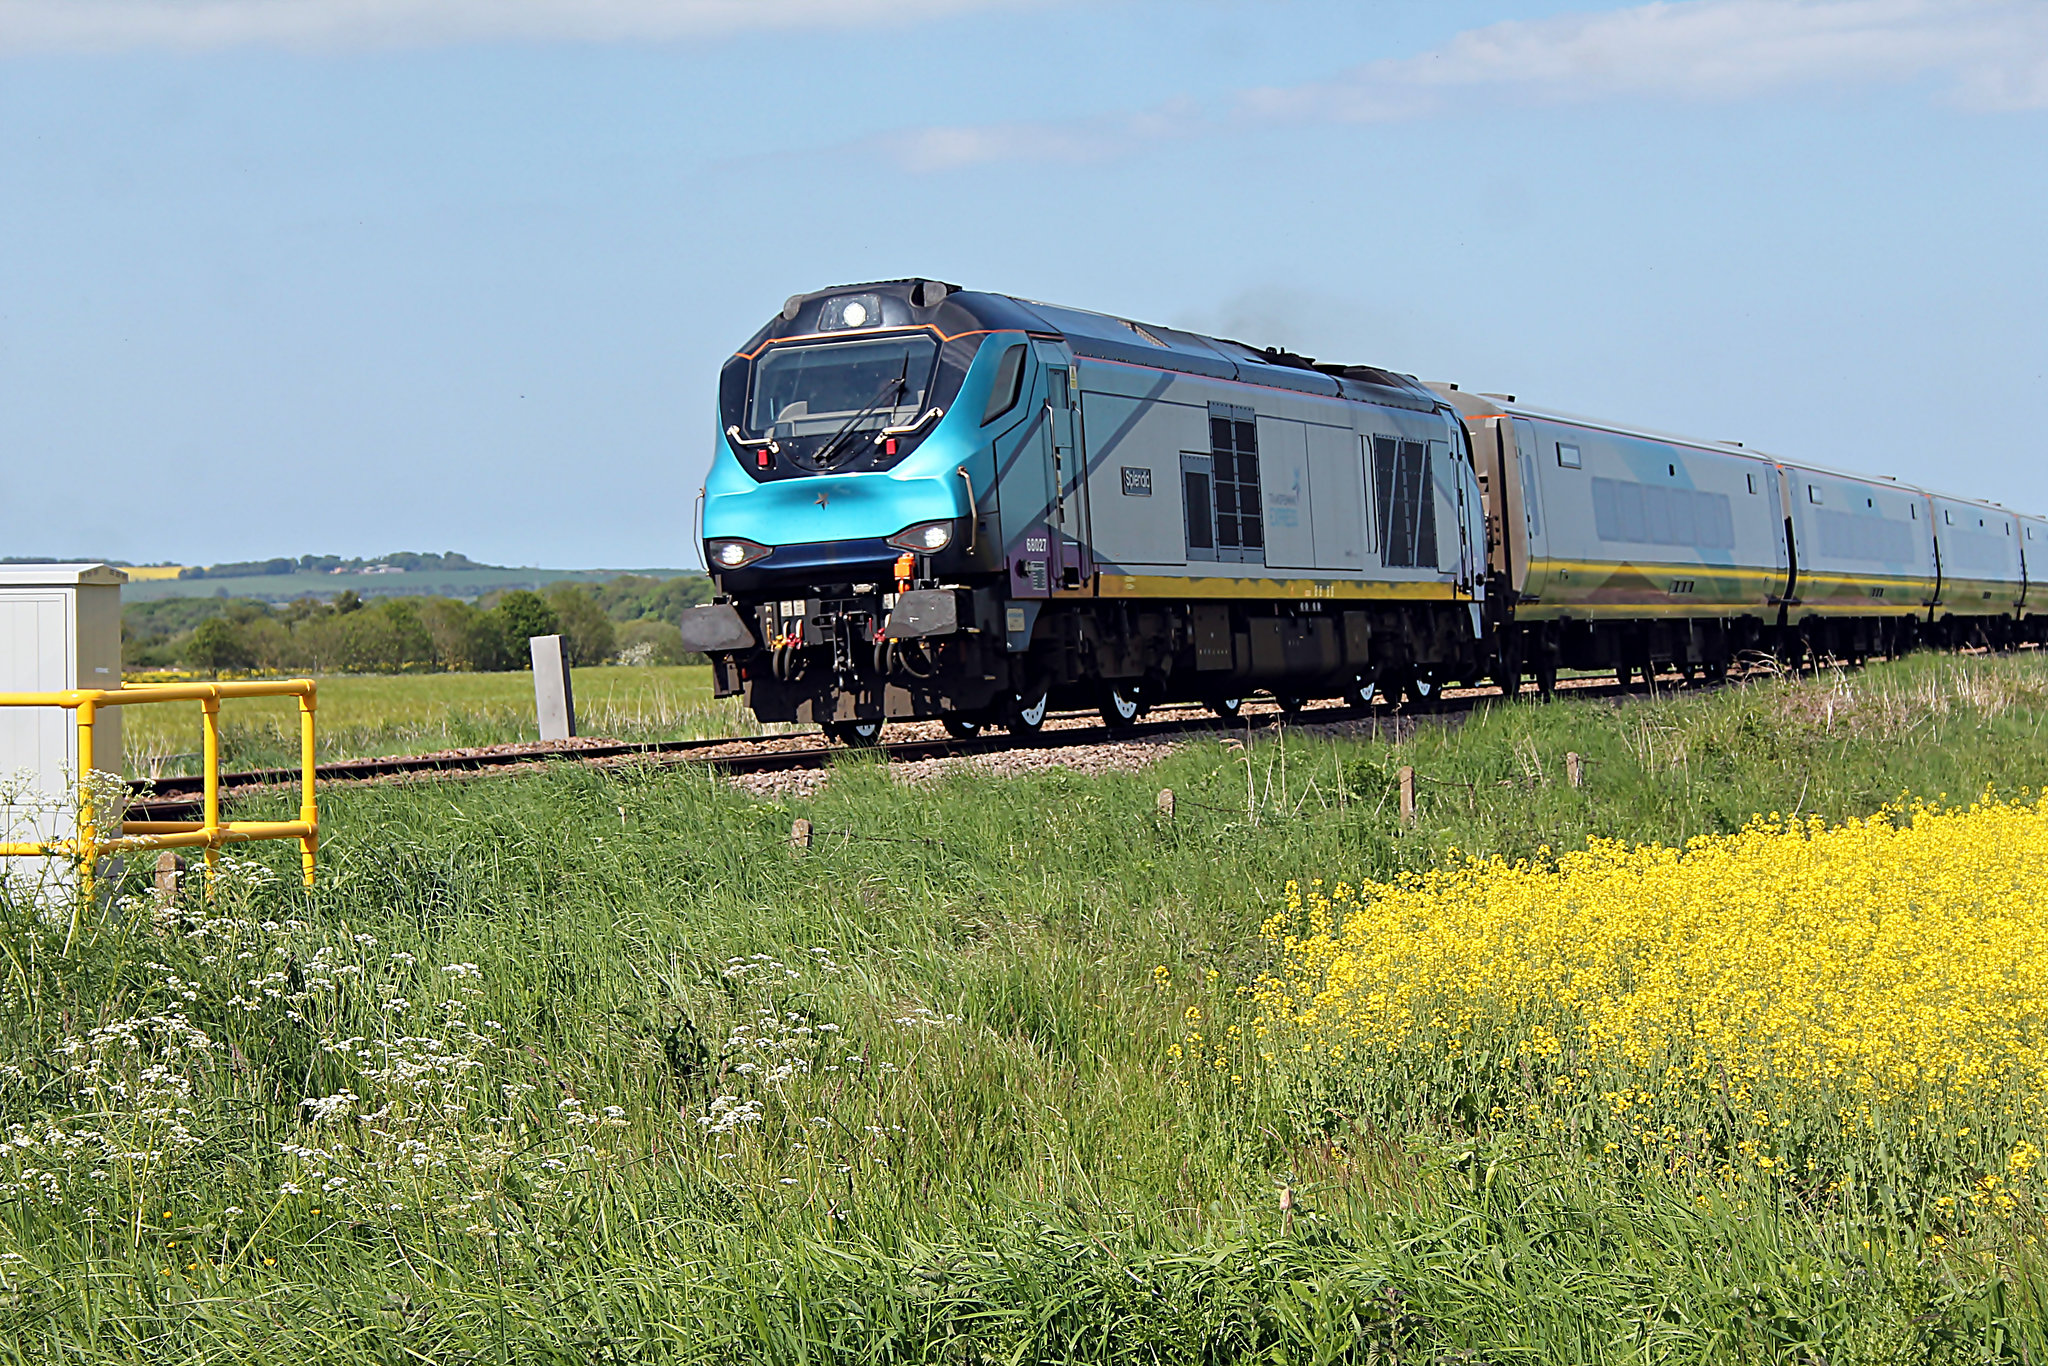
[0,0,2048,567]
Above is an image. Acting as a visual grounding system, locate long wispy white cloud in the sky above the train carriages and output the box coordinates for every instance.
[877,0,2048,170]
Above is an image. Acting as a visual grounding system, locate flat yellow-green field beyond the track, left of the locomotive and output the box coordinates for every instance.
[123,666,760,776]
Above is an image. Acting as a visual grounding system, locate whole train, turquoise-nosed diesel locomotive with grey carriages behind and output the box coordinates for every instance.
[682,281,2048,743]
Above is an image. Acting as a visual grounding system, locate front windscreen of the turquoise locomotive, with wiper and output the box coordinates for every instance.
[748,332,938,438]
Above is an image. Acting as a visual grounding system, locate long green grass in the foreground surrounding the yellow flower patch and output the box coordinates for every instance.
[0,657,2048,1362]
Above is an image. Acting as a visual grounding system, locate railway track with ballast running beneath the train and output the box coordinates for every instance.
[129,678,1702,821]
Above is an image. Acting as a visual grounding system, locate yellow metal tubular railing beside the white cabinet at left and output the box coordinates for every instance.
[0,678,319,889]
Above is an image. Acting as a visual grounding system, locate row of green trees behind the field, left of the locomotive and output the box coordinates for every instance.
[121,575,711,674]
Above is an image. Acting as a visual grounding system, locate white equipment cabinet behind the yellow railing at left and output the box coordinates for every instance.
[0,565,127,862]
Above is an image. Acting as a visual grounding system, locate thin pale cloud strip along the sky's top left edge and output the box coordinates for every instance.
[0,0,1020,53]
